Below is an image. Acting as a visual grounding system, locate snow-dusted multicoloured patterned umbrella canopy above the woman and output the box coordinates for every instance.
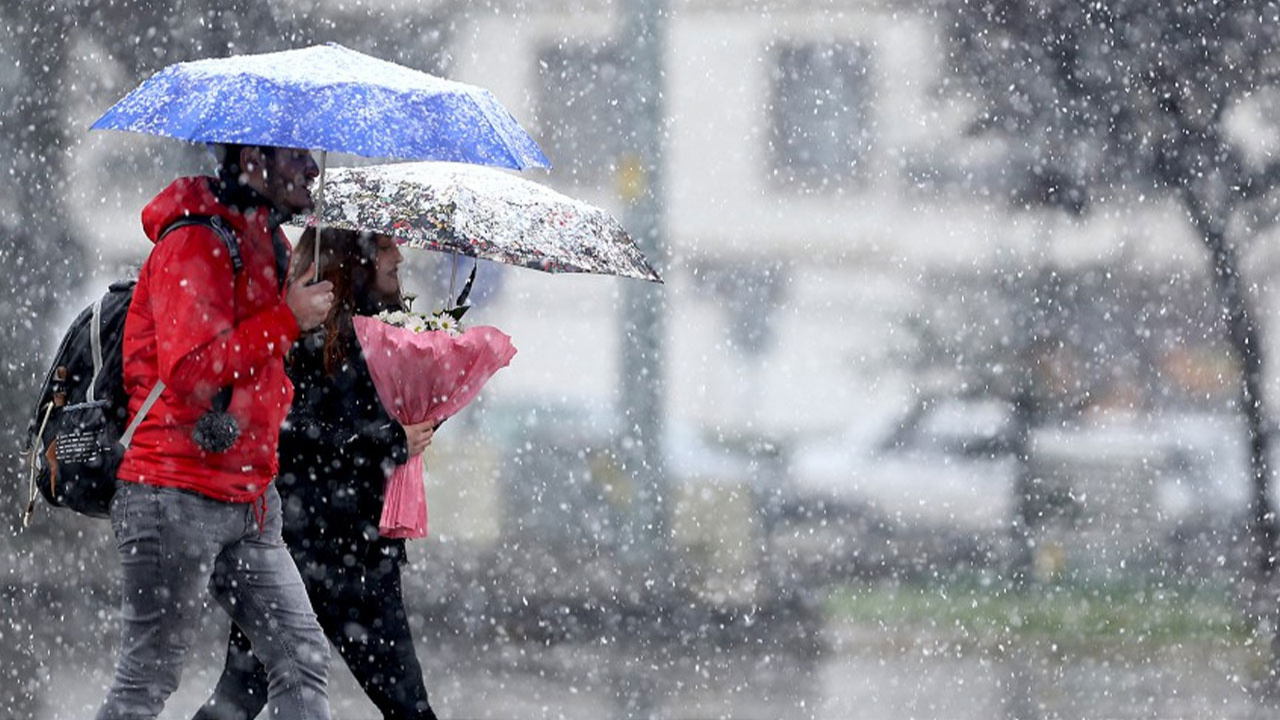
[297,163,662,283]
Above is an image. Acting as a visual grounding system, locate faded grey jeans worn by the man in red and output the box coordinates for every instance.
[97,482,329,720]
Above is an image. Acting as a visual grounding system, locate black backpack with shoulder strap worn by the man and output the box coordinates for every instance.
[23,215,243,525]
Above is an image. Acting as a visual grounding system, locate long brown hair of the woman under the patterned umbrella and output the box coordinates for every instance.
[289,228,404,375]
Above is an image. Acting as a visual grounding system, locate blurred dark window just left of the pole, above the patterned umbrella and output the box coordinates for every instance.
[538,42,627,184]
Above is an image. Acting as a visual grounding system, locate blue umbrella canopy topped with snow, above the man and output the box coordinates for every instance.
[92,42,550,169]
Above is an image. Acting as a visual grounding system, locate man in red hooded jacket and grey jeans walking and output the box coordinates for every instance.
[97,146,333,720]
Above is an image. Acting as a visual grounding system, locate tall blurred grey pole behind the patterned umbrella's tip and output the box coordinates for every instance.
[618,0,668,566]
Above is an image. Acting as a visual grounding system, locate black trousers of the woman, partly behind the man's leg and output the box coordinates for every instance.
[196,556,435,720]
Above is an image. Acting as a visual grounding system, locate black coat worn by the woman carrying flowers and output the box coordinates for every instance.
[278,325,408,573]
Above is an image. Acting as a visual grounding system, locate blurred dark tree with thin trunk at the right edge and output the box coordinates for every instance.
[936,0,1280,678]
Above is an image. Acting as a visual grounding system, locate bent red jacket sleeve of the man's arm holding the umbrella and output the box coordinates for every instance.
[150,225,298,405]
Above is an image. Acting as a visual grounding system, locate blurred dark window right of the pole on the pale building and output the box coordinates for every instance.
[769,42,872,190]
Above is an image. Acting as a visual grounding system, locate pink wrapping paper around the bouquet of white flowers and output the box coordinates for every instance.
[353,316,516,538]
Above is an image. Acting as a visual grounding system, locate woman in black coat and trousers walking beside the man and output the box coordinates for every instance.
[196,229,435,720]
